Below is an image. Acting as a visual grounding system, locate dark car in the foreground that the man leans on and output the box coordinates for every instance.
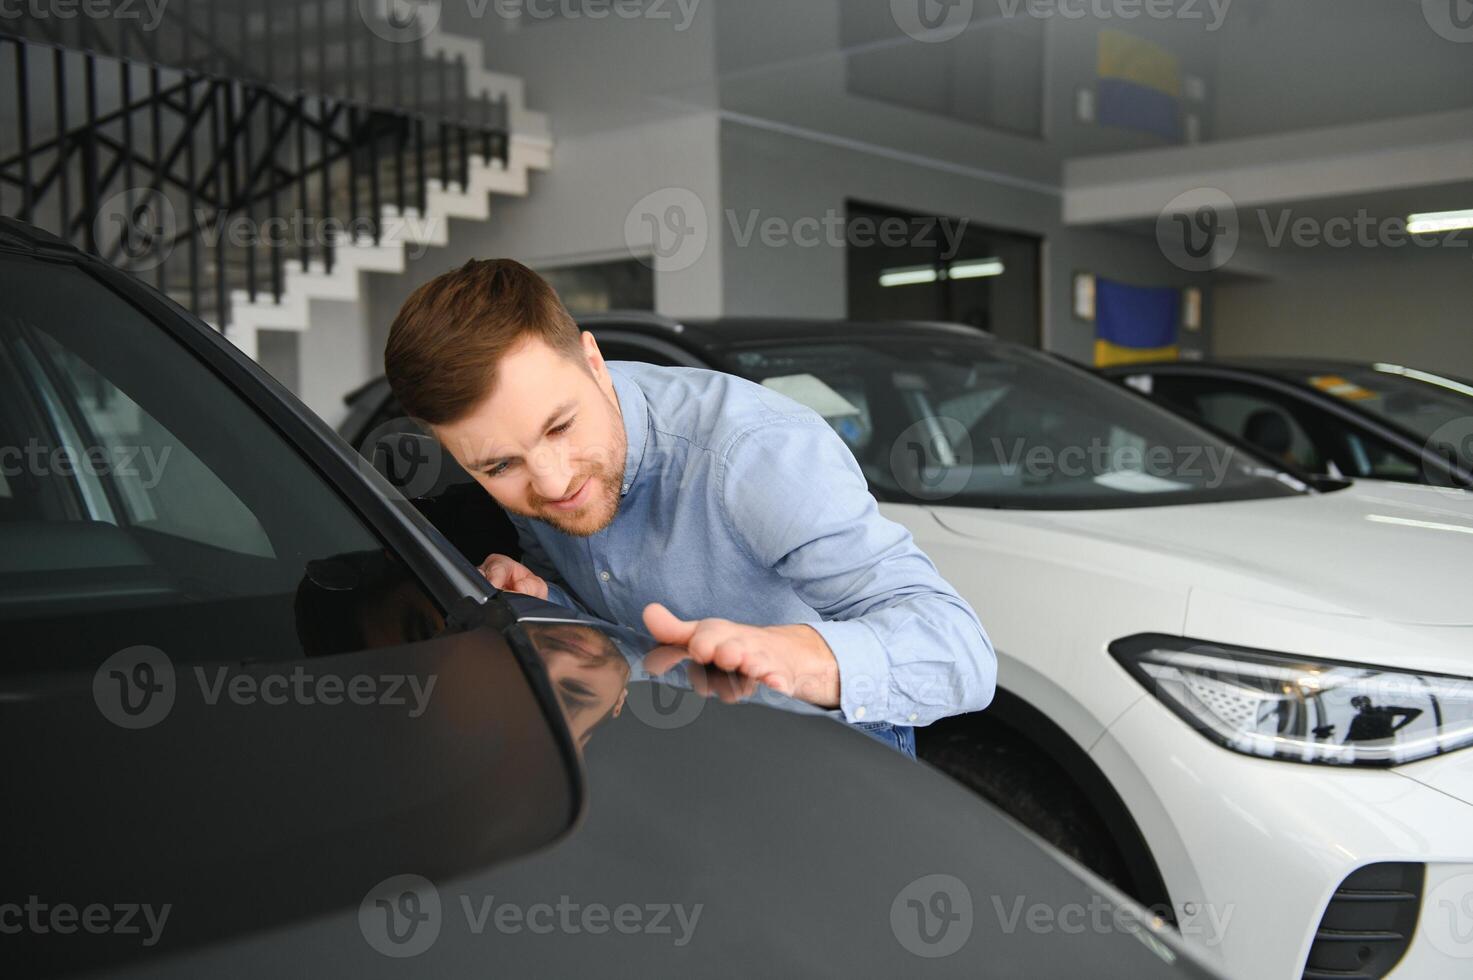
[0,220,1211,977]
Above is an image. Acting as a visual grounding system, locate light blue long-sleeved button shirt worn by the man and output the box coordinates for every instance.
[513,361,997,725]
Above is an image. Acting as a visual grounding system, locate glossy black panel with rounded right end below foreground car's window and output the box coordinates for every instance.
[0,604,582,976]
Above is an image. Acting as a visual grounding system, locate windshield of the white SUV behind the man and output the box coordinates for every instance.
[728,335,1305,510]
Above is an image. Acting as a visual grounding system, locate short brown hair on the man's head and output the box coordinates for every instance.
[383,258,582,424]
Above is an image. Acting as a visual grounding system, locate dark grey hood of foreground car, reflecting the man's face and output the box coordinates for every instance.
[106,601,1230,980]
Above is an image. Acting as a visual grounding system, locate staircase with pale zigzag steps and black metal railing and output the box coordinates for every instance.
[0,0,551,357]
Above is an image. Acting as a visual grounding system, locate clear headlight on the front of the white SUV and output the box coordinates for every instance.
[1109,635,1473,766]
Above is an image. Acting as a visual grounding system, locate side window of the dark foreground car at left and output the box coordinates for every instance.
[0,256,442,671]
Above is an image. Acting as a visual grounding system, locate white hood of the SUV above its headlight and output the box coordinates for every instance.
[932,480,1473,626]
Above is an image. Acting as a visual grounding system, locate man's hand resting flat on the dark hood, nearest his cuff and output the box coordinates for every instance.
[644,603,840,707]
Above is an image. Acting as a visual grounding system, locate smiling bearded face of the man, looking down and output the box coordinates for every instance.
[432,333,627,536]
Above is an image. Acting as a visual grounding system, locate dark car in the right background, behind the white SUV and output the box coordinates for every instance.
[1102,358,1473,488]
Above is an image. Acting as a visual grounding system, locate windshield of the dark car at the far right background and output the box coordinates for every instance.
[1298,364,1473,470]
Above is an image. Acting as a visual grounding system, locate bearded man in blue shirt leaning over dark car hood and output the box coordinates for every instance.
[384,259,997,755]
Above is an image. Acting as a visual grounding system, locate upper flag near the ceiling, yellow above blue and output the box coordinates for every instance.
[1096,31,1181,143]
